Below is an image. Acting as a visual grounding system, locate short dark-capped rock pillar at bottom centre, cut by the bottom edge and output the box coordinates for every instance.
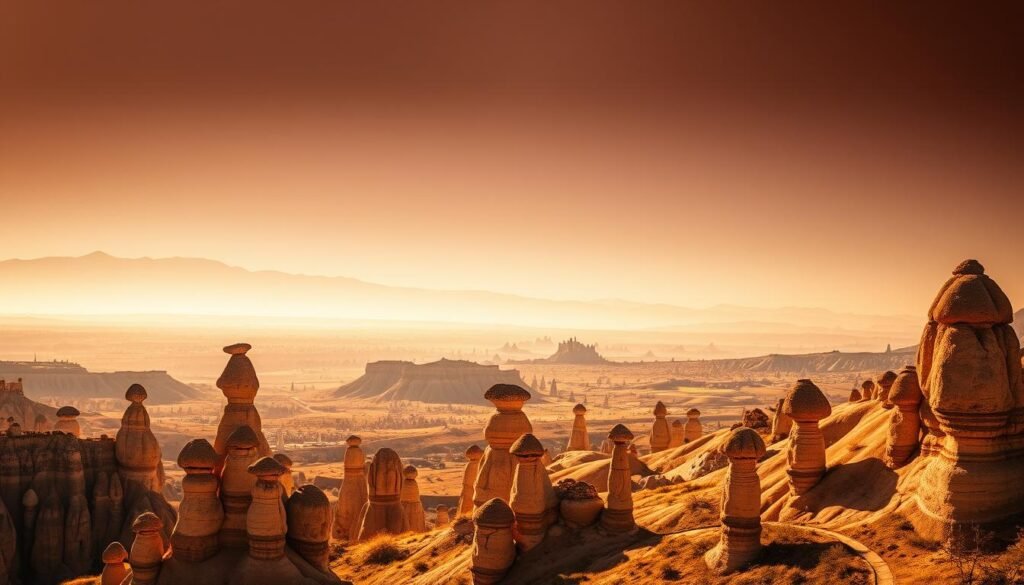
[471,498,515,585]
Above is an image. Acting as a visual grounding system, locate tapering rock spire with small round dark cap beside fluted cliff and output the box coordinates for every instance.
[114,384,164,493]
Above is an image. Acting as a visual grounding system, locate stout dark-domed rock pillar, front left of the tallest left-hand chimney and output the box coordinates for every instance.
[171,438,224,562]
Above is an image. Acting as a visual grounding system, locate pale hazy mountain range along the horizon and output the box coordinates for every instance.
[0,252,922,337]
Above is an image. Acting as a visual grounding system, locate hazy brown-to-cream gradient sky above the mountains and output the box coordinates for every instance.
[0,0,1024,315]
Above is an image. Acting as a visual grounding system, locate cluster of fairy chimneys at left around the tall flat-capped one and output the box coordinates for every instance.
[101,343,340,585]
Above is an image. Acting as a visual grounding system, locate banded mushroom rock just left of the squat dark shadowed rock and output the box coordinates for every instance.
[246,457,288,560]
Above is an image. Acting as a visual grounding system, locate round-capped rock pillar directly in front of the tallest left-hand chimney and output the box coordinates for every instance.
[219,425,259,548]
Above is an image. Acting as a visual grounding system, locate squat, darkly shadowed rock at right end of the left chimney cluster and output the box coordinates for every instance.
[286,484,332,573]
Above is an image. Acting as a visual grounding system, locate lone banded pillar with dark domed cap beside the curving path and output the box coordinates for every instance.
[705,427,766,574]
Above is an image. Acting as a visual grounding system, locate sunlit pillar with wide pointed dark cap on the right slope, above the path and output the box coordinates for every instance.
[782,380,831,496]
